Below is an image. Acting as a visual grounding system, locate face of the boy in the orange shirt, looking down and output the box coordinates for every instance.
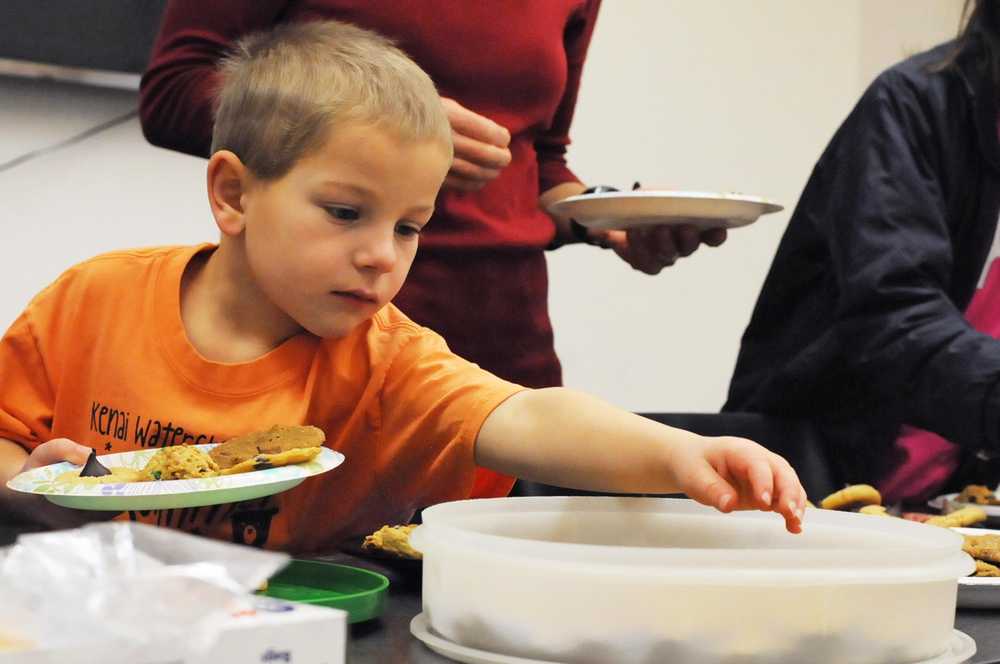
[242,124,451,338]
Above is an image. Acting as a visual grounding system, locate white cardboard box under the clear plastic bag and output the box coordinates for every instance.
[0,596,347,664]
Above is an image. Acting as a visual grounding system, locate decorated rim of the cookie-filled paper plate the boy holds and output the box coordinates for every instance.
[7,444,344,497]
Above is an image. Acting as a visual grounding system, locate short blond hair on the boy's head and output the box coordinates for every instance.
[212,21,451,180]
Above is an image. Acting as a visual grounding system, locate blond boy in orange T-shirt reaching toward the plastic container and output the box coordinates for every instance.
[0,22,805,553]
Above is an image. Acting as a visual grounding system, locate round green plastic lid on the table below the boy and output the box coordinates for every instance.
[259,560,389,623]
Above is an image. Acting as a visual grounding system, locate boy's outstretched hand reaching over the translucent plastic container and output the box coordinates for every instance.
[674,436,806,533]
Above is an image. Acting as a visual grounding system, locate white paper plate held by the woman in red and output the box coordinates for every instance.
[549,190,784,231]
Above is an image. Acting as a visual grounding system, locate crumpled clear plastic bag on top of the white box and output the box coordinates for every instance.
[0,522,289,664]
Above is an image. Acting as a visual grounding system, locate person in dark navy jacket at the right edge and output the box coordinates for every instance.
[724,0,1000,501]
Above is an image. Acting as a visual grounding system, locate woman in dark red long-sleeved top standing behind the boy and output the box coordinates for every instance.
[140,0,725,496]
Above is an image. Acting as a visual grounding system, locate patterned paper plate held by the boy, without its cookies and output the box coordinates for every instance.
[7,445,344,512]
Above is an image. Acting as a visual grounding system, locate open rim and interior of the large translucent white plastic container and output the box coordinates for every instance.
[410,497,972,585]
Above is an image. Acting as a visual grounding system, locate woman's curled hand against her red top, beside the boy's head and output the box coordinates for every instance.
[441,98,511,191]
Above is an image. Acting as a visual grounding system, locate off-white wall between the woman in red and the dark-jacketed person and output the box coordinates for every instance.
[550,0,961,411]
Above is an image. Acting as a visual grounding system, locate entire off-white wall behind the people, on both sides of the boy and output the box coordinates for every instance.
[0,0,961,411]
